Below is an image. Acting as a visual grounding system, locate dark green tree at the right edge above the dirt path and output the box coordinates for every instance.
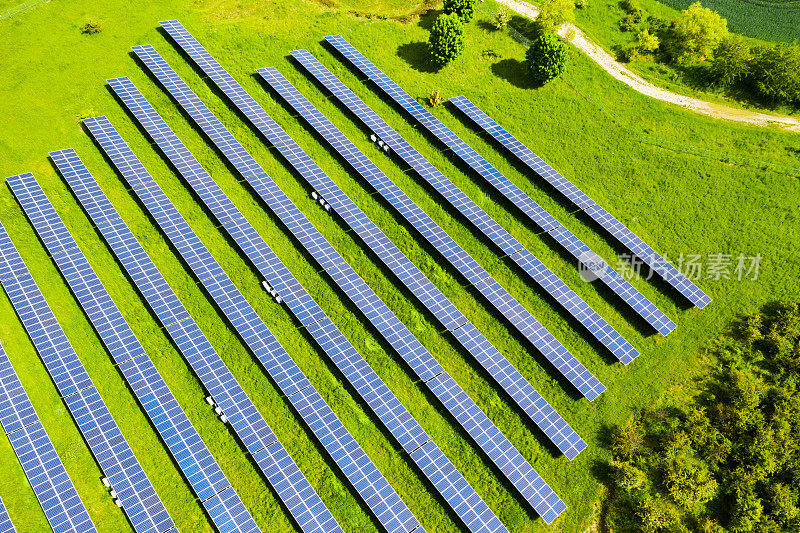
[752,43,800,103]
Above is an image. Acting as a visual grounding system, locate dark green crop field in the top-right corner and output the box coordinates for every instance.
[662,0,800,41]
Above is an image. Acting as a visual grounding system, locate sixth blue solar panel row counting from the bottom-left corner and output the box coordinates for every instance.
[84,117,428,532]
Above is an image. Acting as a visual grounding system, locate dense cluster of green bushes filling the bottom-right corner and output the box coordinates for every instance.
[608,303,800,533]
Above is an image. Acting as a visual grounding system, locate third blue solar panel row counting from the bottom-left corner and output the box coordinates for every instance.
[0,224,175,533]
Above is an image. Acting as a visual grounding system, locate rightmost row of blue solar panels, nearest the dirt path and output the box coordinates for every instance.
[450,96,711,309]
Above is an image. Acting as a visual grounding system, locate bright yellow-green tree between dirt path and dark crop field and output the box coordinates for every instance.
[669,2,728,61]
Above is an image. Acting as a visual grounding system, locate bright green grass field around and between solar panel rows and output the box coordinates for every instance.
[0,0,800,533]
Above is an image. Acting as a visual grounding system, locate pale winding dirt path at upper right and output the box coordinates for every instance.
[497,0,800,132]
